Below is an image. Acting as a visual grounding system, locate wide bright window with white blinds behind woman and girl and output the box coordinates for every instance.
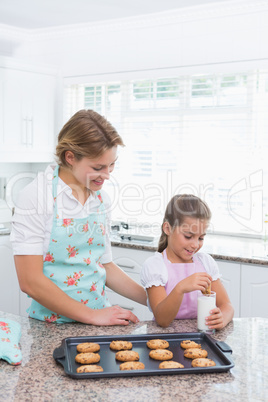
[65,71,268,236]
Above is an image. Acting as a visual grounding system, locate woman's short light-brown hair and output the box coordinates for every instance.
[56,110,124,167]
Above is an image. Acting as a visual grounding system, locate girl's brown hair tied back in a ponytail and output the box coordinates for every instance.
[158,194,211,253]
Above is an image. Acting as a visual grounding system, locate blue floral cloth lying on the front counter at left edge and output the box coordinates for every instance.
[0,317,22,366]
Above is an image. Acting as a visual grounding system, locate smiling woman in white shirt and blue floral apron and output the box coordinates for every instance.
[11,110,146,325]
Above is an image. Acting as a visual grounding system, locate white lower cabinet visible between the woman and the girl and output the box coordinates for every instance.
[108,247,153,321]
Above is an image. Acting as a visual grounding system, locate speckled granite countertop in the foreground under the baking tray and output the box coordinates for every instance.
[0,312,268,402]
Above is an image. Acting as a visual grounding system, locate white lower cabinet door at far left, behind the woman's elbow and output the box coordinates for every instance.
[0,236,20,314]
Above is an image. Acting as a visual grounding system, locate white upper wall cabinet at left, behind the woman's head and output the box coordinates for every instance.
[0,58,57,162]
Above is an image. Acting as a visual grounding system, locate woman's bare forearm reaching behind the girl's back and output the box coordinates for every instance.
[103,261,147,306]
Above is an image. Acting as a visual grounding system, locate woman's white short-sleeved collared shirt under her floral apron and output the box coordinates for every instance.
[10,165,112,264]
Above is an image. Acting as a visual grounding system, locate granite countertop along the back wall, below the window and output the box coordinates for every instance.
[111,234,268,267]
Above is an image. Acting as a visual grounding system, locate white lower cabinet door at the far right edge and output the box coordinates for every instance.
[241,265,268,318]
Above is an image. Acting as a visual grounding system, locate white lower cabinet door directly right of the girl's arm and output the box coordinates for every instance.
[217,260,241,317]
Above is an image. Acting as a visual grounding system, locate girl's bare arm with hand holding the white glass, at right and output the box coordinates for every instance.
[207,279,234,329]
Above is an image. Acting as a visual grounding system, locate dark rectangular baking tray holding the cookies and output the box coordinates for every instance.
[53,332,234,379]
